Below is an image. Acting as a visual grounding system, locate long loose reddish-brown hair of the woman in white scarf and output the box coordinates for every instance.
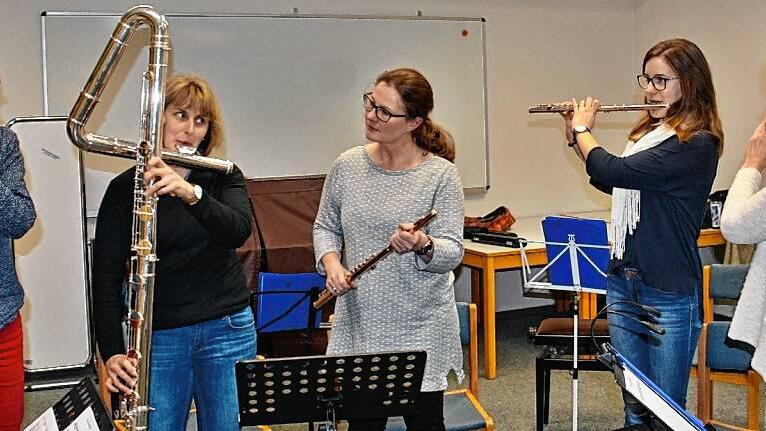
[629,39,723,157]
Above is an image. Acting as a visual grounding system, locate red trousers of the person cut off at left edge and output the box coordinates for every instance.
[0,316,24,431]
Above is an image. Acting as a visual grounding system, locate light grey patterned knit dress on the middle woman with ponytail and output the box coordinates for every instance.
[314,146,463,392]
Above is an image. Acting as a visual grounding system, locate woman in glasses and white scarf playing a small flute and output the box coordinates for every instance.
[563,39,723,425]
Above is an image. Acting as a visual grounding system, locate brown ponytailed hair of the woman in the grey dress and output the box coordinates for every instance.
[375,68,455,162]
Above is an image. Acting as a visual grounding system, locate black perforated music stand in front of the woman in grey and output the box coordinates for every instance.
[235,351,426,431]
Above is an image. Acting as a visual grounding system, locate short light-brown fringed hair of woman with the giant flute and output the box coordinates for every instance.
[165,74,224,156]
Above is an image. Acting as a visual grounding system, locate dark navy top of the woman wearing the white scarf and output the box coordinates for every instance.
[586,131,718,294]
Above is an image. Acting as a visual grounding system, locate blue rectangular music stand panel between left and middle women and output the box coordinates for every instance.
[256,272,325,333]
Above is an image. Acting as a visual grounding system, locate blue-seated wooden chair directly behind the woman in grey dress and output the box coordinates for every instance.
[386,302,495,431]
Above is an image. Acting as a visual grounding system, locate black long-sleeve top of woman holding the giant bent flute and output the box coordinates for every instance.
[93,168,252,361]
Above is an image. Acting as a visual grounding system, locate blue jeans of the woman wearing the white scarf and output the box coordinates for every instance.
[606,268,702,425]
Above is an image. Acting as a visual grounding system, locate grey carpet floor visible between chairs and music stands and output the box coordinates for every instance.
[24,308,764,431]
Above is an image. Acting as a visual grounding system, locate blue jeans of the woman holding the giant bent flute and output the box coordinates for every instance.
[149,307,256,431]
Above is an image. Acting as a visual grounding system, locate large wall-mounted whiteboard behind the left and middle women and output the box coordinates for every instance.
[42,11,489,210]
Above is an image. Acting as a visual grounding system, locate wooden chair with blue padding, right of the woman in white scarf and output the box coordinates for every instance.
[697,265,761,430]
